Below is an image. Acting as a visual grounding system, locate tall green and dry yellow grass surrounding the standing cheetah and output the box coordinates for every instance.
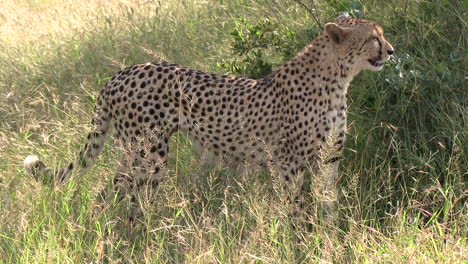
[0,0,468,263]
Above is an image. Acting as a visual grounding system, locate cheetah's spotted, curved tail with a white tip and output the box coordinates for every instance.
[23,94,112,184]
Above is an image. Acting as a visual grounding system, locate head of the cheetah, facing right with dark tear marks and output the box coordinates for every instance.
[324,16,394,73]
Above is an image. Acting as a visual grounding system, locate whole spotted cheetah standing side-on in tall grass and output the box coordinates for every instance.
[24,16,394,210]
